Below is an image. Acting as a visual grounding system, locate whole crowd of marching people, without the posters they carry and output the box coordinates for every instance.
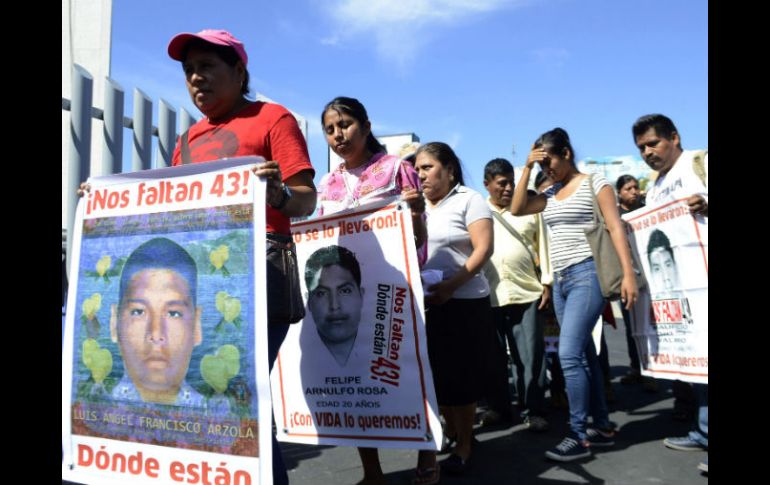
[69,30,708,485]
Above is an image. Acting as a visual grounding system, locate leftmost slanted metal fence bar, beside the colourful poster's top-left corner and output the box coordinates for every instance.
[66,64,94,276]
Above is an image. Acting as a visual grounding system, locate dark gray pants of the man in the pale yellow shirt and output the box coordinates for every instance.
[485,299,545,416]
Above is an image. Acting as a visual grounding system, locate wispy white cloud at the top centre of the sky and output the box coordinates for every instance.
[321,0,530,71]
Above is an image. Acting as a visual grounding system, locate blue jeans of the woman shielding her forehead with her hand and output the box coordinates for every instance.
[553,258,610,440]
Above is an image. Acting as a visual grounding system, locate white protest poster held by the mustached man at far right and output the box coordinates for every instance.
[623,199,708,383]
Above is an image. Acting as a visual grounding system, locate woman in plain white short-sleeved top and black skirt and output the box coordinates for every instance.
[415,142,496,475]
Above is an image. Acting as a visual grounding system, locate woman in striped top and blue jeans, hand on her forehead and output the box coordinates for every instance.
[511,128,638,461]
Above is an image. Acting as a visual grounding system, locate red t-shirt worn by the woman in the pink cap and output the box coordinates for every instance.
[172,101,315,234]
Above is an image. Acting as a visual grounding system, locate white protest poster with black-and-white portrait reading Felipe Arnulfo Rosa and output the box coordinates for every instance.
[271,201,442,449]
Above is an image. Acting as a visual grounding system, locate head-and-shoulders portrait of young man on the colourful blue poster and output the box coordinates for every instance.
[110,237,205,407]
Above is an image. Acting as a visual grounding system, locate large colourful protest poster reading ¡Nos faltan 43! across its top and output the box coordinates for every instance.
[62,157,272,485]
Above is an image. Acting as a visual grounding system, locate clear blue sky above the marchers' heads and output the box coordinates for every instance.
[111,0,708,190]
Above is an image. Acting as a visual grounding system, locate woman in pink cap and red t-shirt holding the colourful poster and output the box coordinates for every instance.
[168,30,316,484]
